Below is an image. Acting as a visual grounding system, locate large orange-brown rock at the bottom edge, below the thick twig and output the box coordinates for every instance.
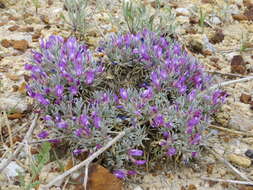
[88,164,123,190]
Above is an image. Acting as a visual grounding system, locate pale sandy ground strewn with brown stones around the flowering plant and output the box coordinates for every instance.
[0,0,253,190]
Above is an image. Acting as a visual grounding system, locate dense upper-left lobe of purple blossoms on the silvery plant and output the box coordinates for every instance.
[25,36,104,106]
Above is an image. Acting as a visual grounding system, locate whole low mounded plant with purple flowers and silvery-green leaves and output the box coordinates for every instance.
[25,30,226,178]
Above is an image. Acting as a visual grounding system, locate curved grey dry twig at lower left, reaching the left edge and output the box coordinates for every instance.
[0,114,38,173]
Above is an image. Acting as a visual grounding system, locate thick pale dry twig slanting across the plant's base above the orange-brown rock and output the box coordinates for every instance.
[42,131,126,189]
